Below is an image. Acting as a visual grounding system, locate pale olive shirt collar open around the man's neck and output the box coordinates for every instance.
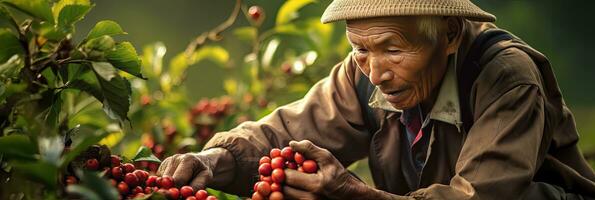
[368,54,463,131]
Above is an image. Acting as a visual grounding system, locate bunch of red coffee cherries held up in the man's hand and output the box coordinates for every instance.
[252,147,318,200]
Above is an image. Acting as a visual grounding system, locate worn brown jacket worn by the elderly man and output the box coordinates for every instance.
[205,21,595,199]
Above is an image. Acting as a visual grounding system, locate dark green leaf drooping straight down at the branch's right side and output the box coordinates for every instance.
[92,62,132,122]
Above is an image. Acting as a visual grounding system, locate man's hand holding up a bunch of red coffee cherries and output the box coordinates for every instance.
[283,140,408,199]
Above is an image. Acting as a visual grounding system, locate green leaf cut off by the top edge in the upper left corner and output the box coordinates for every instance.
[3,0,54,23]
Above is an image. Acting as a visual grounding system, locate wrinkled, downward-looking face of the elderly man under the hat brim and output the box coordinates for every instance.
[347,17,448,109]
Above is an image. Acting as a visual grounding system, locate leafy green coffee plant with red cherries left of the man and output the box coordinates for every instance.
[0,0,349,199]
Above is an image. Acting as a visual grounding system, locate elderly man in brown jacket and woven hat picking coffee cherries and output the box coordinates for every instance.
[159,0,595,199]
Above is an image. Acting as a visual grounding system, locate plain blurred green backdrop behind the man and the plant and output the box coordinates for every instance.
[75,0,595,164]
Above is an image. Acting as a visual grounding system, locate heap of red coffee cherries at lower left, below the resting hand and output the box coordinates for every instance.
[66,155,217,200]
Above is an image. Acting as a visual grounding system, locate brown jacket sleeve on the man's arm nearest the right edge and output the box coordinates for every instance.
[409,48,561,199]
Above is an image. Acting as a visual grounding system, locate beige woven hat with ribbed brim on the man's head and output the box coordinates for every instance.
[321,0,496,23]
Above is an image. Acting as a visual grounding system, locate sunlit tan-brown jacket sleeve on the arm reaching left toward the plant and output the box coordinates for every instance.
[205,56,369,195]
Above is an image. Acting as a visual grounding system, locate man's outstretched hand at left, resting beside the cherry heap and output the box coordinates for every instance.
[157,148,235,190]
